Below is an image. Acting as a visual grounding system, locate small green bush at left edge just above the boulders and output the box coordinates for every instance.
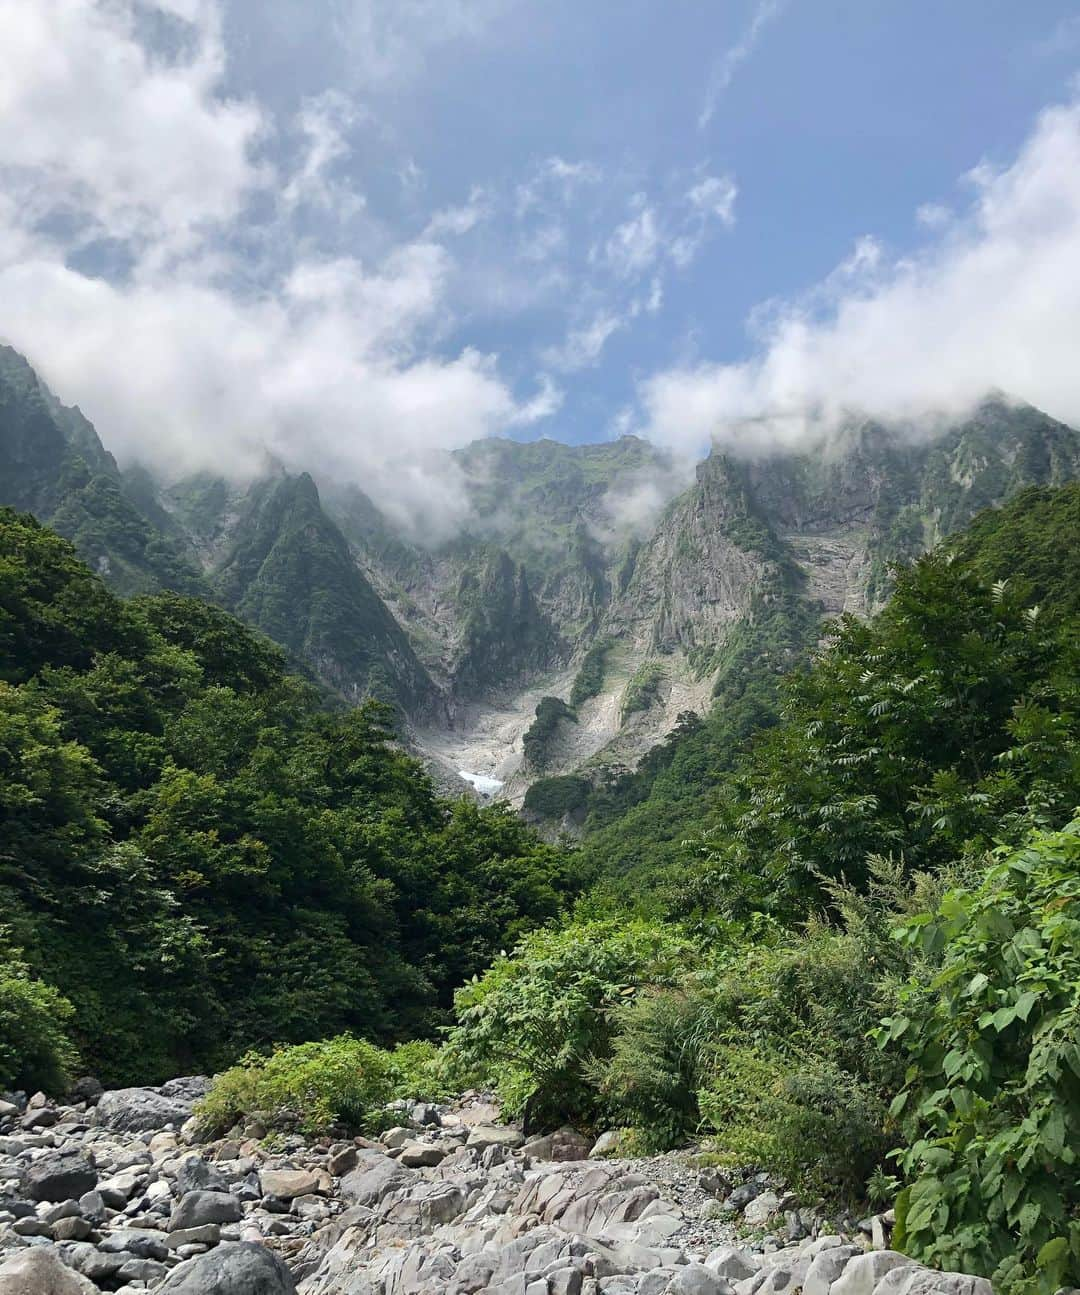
[0,960,79,1094]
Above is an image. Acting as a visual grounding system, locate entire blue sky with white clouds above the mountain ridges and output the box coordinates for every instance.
[0,0,1080,528]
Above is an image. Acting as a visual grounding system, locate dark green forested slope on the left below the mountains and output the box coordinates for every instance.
[0,512,574,1083]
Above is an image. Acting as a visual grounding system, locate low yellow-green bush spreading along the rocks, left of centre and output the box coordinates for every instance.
[198,1035,416,1133]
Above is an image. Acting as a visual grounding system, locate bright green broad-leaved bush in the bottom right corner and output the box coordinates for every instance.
[878,818,1080,1292]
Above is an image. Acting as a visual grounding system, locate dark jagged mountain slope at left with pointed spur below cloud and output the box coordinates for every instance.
[0,347,442,720]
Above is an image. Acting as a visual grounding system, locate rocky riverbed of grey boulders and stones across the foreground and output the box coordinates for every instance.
[0,1077,991,1295]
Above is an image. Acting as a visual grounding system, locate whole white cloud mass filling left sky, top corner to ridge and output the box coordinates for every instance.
[0,0,546,536]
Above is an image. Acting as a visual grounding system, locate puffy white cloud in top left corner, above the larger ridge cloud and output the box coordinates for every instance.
[0,0,265,254]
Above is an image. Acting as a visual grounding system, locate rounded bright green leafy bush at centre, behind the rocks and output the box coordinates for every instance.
[448,921,694,1123]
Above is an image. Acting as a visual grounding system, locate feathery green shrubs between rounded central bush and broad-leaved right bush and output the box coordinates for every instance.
[594,861,938,1200]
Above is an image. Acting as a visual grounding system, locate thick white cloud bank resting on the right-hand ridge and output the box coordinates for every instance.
[640,104,1080,463]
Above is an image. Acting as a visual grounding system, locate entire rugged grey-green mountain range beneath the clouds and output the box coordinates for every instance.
[0,341,1080,787]
